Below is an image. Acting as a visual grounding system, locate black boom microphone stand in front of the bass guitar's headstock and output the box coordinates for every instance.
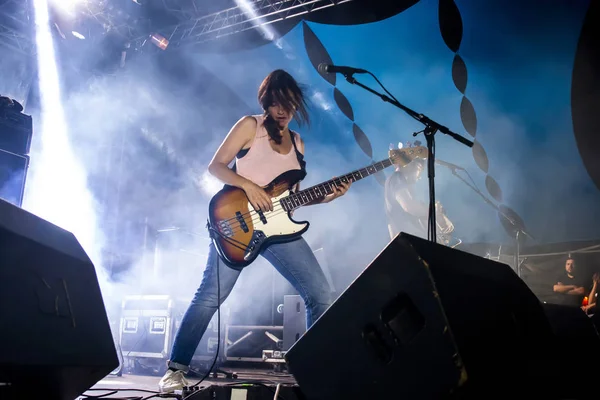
[343,72,473,243]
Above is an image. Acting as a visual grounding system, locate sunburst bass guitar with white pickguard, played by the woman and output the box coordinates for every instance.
[207,146,427,270]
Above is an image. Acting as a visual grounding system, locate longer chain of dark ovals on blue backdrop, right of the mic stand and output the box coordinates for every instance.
[438,0,525,237]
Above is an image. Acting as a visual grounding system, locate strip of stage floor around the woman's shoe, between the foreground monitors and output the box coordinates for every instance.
[82,368,298,400]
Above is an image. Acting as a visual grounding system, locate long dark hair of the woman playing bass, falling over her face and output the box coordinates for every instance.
[258,69,310,144]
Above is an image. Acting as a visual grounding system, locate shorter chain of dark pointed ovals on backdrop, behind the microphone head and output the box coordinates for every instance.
[302,21,385,186]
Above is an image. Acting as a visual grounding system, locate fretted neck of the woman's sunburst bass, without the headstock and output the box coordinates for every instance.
[281,158,393,211]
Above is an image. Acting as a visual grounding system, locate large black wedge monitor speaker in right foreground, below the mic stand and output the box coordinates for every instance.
[285,233,556,400]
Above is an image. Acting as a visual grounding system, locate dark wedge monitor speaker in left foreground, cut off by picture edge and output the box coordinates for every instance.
[0,200,119,400]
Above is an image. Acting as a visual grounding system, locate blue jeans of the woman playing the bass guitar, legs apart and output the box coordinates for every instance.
[169,238,331,372]
